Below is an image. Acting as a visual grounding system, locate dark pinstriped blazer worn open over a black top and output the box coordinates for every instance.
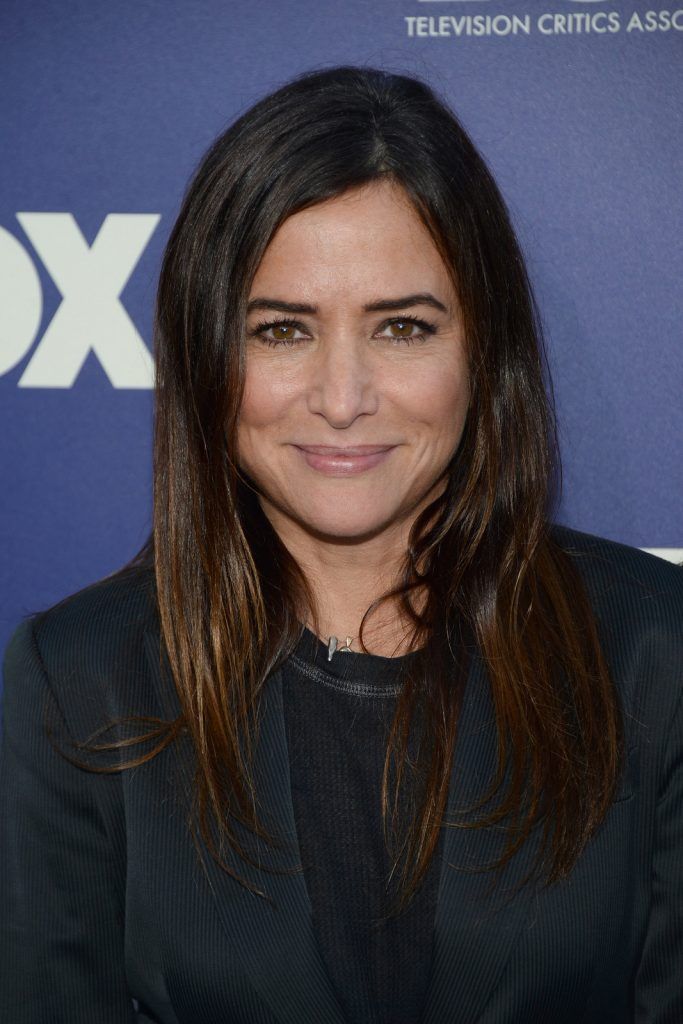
[0,530,683,1024]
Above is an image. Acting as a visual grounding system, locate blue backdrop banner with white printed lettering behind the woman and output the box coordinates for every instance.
[0,0,683,648]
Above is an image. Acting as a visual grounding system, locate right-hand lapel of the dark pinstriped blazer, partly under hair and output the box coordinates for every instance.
[422,656,538,1024]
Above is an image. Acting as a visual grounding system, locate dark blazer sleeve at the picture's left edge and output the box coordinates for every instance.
[0,621,139,1024]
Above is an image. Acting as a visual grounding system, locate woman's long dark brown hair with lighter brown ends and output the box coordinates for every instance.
[62,67,622,906]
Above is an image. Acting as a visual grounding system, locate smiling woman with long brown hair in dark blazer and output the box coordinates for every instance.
[0,68,683,1024]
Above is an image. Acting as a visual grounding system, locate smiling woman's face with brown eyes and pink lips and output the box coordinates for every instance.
[238,182,469,557]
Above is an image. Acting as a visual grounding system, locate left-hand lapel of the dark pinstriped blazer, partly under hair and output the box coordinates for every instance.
[144,630,344,1024]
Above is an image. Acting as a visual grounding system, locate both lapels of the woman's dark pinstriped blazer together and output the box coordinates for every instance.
[144,630,532,1024]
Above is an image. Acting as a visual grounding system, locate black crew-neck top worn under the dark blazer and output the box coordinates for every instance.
[283,629,441,1024]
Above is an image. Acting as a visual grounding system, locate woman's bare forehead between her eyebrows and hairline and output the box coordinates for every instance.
[251,181,453,302]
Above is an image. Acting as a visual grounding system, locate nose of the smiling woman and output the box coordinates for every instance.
[308,337,378,429]
